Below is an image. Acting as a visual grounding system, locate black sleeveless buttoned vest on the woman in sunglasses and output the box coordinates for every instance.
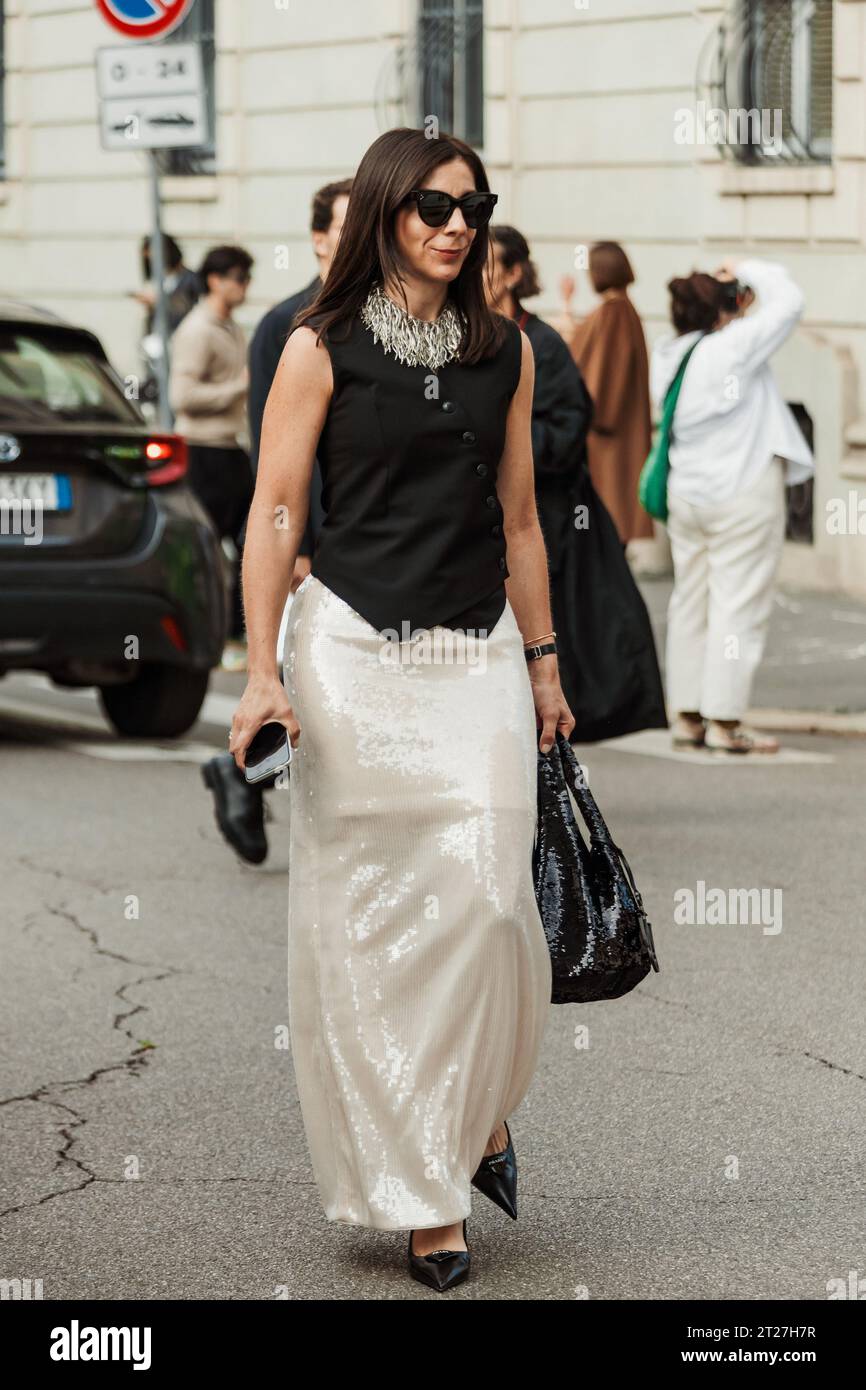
[311,309,521,641]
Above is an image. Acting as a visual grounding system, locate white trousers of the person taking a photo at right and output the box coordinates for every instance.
[667,459,785,719]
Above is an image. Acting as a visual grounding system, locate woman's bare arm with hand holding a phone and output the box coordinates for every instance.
[231,328,334,767]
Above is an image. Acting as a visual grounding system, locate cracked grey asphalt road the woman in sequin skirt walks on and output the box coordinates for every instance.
[0,636,866,1300]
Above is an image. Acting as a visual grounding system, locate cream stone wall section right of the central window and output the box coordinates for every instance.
[489,0,866,591]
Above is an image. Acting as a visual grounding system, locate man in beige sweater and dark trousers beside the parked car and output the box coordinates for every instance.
[168,246,253,669]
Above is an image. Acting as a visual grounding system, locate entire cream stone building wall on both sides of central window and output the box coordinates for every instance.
[0,0,866,589]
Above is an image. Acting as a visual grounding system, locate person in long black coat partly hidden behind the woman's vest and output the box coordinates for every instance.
[488,225,667,742]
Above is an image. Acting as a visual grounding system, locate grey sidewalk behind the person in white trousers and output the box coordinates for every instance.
[638,578,866,734]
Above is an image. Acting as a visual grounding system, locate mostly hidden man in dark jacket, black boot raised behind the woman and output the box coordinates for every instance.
[202,179,352,863]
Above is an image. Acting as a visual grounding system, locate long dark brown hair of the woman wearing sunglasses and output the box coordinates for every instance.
[295,126,506,366]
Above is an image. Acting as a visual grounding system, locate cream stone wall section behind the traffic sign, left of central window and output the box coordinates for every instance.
[0,0,411,371]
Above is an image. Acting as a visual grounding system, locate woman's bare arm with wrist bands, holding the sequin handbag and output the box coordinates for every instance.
[496,332,574,753]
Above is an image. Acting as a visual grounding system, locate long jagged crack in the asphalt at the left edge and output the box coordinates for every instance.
[0,905,185,1220]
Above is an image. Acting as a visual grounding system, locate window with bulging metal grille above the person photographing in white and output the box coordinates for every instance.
[698,0,833,165]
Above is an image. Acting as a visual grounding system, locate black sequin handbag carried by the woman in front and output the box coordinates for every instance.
[532,734,659,1004]
